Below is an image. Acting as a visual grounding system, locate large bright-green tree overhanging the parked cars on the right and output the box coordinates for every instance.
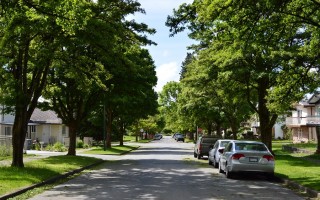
[167,0,314,149]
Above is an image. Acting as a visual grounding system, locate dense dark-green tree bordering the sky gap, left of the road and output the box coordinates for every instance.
[105,45,158,147]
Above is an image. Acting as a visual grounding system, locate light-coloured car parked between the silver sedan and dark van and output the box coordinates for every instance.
[208,139,232,168]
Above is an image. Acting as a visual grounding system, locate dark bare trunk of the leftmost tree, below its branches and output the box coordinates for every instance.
[11,108,28,168]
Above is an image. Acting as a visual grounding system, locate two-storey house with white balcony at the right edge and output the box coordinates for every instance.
[286,92,320,143]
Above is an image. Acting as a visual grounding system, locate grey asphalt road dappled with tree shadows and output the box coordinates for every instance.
[32,138,304,200]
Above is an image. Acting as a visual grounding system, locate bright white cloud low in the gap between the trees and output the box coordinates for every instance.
[155,62,181,92]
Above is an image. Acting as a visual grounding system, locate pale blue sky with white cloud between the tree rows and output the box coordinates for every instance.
[134,0,193,92]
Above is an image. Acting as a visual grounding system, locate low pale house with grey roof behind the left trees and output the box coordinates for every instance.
[0,108,69,148]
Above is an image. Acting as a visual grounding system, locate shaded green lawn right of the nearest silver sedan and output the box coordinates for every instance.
[273,141,320,191]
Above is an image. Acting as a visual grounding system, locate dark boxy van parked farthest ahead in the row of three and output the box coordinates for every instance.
[193,136,219,159]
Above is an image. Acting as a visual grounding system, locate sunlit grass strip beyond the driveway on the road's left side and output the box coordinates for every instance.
[83,145,139,155]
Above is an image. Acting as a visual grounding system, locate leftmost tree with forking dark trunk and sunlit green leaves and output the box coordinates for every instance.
[0,1,81,167]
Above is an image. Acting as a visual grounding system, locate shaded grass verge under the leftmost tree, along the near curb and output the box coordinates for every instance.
[0,156,100,195]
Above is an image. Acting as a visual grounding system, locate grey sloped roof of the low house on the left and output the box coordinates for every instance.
[30,108,62,124]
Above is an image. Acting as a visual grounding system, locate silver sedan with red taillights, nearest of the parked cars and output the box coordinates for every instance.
[219,140,275,178]
